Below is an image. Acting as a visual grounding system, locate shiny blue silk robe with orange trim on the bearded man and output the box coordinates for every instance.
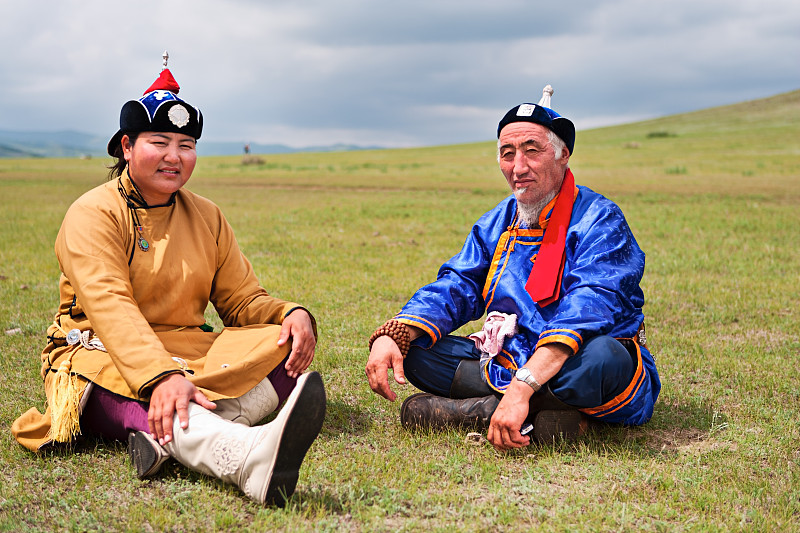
[395,186,661,424]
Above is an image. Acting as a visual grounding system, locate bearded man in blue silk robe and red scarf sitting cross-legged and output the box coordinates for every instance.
[366,85,661,450]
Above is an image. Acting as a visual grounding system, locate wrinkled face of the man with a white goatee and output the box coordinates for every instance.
[498,122,569,207]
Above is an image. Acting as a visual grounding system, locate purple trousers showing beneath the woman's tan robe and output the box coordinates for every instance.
[81,357,297,441]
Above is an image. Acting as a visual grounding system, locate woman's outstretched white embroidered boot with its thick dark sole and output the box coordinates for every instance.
[164,372,326,505]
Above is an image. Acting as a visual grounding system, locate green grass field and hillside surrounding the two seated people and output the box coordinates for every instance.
[0,91,800,531]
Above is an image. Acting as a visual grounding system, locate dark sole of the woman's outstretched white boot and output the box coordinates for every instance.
[264,372,326,507]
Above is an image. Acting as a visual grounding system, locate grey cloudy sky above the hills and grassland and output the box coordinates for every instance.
[0,0,800,146]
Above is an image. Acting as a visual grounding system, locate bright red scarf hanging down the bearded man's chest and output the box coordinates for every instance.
[525,169,575,307]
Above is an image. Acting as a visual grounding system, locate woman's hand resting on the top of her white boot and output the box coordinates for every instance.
[147,374,217,446]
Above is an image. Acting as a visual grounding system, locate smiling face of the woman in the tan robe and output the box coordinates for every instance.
[122,131,197,205]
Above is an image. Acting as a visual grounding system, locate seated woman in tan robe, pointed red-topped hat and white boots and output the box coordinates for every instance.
[12,53,325,505]
